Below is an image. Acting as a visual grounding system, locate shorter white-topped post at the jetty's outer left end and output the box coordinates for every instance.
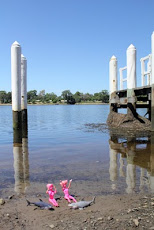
[109,56,118,112]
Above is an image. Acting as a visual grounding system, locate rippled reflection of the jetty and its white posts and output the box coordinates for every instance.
[109,134,154,193]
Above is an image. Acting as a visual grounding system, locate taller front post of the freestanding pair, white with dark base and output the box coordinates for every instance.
[11,41,21,130]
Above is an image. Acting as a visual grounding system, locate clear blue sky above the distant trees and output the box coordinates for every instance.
[0,0,154,95]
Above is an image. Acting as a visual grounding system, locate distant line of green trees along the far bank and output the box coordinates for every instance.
[0,90,109,104]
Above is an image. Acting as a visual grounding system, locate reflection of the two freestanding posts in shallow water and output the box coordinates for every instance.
[13,130,29,194]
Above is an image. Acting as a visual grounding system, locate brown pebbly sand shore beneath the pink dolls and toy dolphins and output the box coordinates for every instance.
[0,194,154,230]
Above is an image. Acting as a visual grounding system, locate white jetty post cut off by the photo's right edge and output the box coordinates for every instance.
[151,32,154,132]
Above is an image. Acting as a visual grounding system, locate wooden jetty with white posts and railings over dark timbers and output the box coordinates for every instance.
[109,32,154,132]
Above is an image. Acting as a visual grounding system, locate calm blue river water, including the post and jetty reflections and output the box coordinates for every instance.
[0,105,154,196]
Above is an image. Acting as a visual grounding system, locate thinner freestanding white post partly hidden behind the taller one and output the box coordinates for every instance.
[21,54,28,138]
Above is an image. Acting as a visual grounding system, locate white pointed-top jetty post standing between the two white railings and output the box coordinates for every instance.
[127,44,136,119]
